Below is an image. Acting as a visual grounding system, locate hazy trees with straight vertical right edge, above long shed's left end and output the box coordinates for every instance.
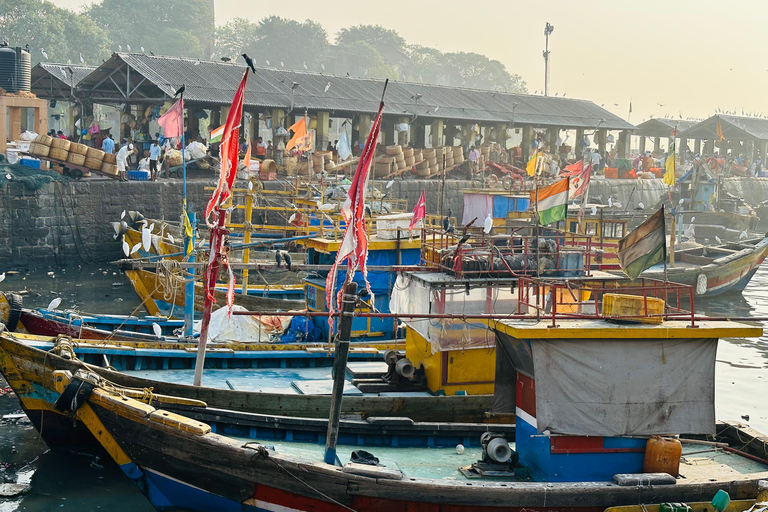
[87,0,214,58]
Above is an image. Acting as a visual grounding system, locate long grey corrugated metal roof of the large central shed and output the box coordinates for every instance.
[79,53,635,130]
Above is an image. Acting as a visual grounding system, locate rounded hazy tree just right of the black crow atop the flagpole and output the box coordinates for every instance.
[249,16,328,71]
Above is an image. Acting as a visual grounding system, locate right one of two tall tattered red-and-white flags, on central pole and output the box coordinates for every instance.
[325,82,387,330]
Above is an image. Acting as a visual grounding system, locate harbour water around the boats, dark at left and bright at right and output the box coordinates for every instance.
[0,265,768,512]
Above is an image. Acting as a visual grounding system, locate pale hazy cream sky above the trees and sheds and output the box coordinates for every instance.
[53,0,768,123]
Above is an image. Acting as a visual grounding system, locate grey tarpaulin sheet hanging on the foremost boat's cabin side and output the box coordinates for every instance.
[532,339,717,436]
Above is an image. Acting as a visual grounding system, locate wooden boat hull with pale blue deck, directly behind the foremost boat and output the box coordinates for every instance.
[0,332,486,451]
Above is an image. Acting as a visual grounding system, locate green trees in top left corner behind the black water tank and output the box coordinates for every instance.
[0,0,110,65]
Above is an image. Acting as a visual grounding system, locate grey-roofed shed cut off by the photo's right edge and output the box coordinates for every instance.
[680,114,768,160]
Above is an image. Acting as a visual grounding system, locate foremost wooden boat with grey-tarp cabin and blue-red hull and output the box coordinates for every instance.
[34,308,768,512]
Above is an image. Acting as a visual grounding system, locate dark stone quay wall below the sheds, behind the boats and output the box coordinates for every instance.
[6,174,768,268]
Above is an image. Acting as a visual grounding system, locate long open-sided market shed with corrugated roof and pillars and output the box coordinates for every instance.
[76,53,634,154]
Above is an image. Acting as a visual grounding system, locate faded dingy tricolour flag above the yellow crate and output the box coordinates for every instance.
[618,206,667,281]
